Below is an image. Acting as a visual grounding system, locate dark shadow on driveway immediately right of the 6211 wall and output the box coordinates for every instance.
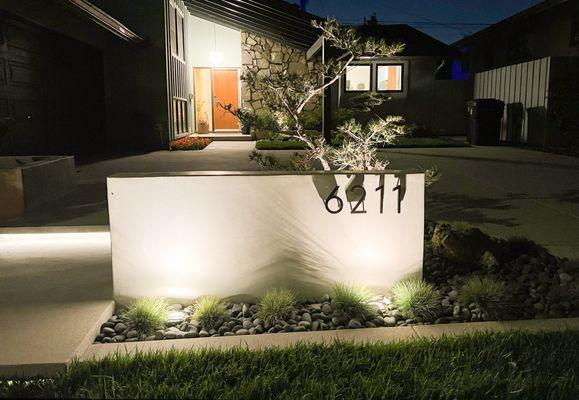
[426,192,520,227]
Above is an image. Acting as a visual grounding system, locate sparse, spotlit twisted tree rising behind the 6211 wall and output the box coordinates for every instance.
[243,19,404,170]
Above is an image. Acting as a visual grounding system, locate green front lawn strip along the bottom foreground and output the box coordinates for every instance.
[0,332,579,400]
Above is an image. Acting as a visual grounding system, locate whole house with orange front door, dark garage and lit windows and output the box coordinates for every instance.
[0,0,465,155]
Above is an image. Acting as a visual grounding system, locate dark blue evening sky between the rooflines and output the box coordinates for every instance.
[286,0,542,43]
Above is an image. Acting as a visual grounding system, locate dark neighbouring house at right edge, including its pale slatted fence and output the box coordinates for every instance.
[454,0,579,147]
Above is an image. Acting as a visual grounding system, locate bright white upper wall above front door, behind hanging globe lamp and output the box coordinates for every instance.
[187,14,241,68]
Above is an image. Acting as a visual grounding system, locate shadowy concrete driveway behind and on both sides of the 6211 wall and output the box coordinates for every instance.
[3,142,579,259]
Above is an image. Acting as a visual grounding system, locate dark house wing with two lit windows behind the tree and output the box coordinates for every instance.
[318,17,467,135]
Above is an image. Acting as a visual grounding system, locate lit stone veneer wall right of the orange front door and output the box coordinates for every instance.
[241,32,317,111]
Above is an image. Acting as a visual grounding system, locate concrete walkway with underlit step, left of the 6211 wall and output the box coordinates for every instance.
[0,228,114,376]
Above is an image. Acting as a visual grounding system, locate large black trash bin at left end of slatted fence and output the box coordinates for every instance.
[466,99,505,146]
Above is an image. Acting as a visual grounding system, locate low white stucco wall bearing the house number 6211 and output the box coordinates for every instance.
[107,172,424,301]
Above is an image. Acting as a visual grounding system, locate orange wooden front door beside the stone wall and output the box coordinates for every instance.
[212,69,239,131]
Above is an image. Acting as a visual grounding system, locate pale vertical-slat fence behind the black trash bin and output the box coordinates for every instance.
[474,57,551,142]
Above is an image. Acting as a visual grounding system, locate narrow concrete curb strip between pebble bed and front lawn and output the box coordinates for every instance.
[79,318,579,360]
